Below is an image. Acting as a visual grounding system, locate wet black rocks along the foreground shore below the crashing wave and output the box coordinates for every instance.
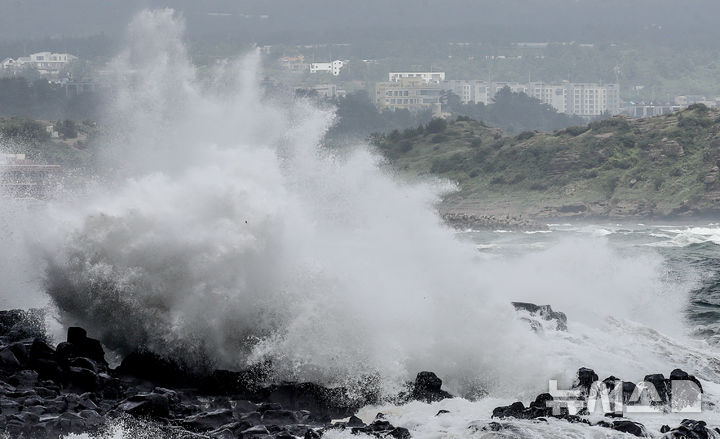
[0,310,720,439]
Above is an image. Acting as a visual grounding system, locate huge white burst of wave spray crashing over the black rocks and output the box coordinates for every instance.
[2,10,717,402]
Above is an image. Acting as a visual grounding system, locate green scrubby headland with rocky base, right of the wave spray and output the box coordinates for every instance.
[374,105,720,218]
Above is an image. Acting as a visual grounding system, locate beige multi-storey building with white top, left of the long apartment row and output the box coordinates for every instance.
[375,77,443,114]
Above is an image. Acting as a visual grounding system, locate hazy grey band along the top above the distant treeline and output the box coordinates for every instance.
[0,0,720,43]
